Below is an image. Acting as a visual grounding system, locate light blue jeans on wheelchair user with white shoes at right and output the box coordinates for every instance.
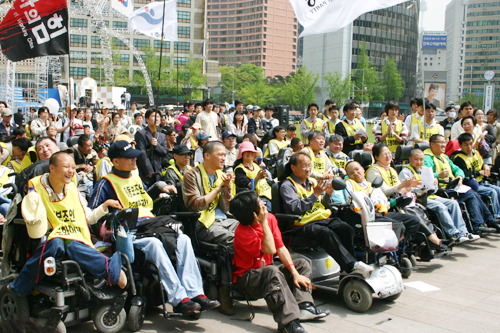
[427,197,468,236]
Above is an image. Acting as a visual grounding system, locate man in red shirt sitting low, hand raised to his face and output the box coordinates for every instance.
[230,191,330,333]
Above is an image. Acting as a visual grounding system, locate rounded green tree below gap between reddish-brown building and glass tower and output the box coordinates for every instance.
[281,66,319,110]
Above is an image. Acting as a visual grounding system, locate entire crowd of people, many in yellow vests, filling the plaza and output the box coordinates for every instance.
[0,95,500,332]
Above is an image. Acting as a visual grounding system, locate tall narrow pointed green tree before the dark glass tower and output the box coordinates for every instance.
[353,41,384,103]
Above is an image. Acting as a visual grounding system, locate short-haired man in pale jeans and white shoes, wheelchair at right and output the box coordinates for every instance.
[399,149,480,244]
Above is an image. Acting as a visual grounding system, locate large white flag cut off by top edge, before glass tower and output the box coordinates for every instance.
[290,0,408,37]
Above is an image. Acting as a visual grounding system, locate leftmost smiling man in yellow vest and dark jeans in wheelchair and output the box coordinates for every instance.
[7,152,127,297]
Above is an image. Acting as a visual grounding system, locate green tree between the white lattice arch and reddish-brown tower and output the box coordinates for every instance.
[177,53,207,99]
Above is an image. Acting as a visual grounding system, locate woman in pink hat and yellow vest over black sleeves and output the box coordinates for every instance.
[234,141,273,211]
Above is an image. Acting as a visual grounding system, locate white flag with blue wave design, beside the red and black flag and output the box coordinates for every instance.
[128,0,177,42]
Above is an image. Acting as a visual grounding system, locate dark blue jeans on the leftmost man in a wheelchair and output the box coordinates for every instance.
[9,238,122,297]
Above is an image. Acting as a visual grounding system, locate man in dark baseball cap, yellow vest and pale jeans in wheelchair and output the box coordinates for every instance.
[90,141,219,313]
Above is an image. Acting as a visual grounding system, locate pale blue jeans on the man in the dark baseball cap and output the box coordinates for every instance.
[134,235,204,306]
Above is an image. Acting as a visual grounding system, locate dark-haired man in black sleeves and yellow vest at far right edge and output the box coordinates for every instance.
[452,133,500,231]
